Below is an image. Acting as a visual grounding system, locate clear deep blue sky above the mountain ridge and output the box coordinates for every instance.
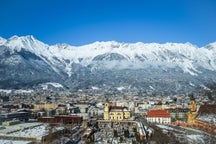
[0,0,216,46]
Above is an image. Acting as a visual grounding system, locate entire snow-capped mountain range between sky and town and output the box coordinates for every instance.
[0,36,216,94]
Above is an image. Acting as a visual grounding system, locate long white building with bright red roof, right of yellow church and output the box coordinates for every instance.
[147,110,171,124]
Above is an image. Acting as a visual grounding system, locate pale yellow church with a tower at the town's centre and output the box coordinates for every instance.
[104,99,130,120]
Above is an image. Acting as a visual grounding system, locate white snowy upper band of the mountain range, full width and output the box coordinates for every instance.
[0,36,216,77]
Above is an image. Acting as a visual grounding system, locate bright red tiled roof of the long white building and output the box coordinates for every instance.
[147,110,170,118]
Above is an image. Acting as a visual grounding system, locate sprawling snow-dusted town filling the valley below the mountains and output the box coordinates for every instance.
[0,91,216,144]
